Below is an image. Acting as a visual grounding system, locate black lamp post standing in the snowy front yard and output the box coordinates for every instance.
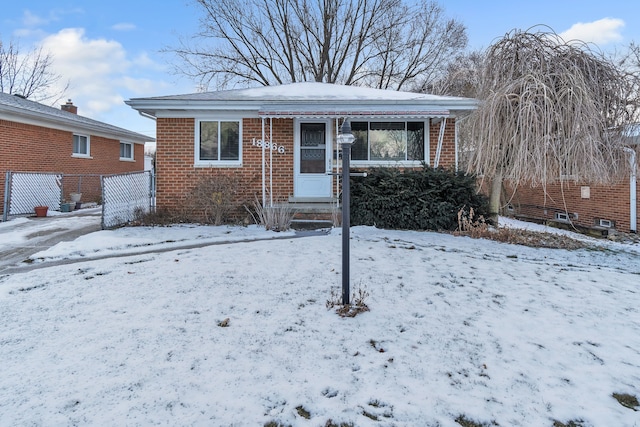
[338,119,356,305]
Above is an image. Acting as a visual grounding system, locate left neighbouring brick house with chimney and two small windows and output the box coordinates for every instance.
[0,93,154,219]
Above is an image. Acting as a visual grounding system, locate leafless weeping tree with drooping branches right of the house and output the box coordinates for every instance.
[467,27,638,219]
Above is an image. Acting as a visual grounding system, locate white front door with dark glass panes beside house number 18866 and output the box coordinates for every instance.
[293,120,332,198]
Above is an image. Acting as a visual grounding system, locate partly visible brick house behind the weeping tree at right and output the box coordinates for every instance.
[505,132,640,236]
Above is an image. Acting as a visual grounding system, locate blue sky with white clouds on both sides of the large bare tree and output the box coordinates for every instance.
[0,0,640,143]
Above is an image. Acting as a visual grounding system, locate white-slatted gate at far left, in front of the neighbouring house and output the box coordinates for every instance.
[2,171,62,221]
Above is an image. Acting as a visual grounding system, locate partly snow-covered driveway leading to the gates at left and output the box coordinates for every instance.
[0,207,102,273]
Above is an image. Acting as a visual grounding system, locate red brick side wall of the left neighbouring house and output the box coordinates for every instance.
[0,120,144,212]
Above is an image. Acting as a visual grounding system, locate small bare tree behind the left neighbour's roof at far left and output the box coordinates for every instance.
[0,40,68,101]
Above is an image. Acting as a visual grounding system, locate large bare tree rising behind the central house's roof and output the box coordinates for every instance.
[167,0,467,90]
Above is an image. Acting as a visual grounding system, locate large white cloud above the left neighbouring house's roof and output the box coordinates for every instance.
[13,21,192,136]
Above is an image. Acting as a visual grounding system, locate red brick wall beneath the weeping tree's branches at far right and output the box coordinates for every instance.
[506,179,640,236]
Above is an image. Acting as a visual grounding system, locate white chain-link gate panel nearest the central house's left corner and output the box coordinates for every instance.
[102,171,153,229]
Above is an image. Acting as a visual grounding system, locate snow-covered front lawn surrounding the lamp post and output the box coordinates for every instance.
[0,222,640,427]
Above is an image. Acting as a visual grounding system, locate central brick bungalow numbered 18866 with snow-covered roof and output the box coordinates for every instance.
[126,83,476,222]
